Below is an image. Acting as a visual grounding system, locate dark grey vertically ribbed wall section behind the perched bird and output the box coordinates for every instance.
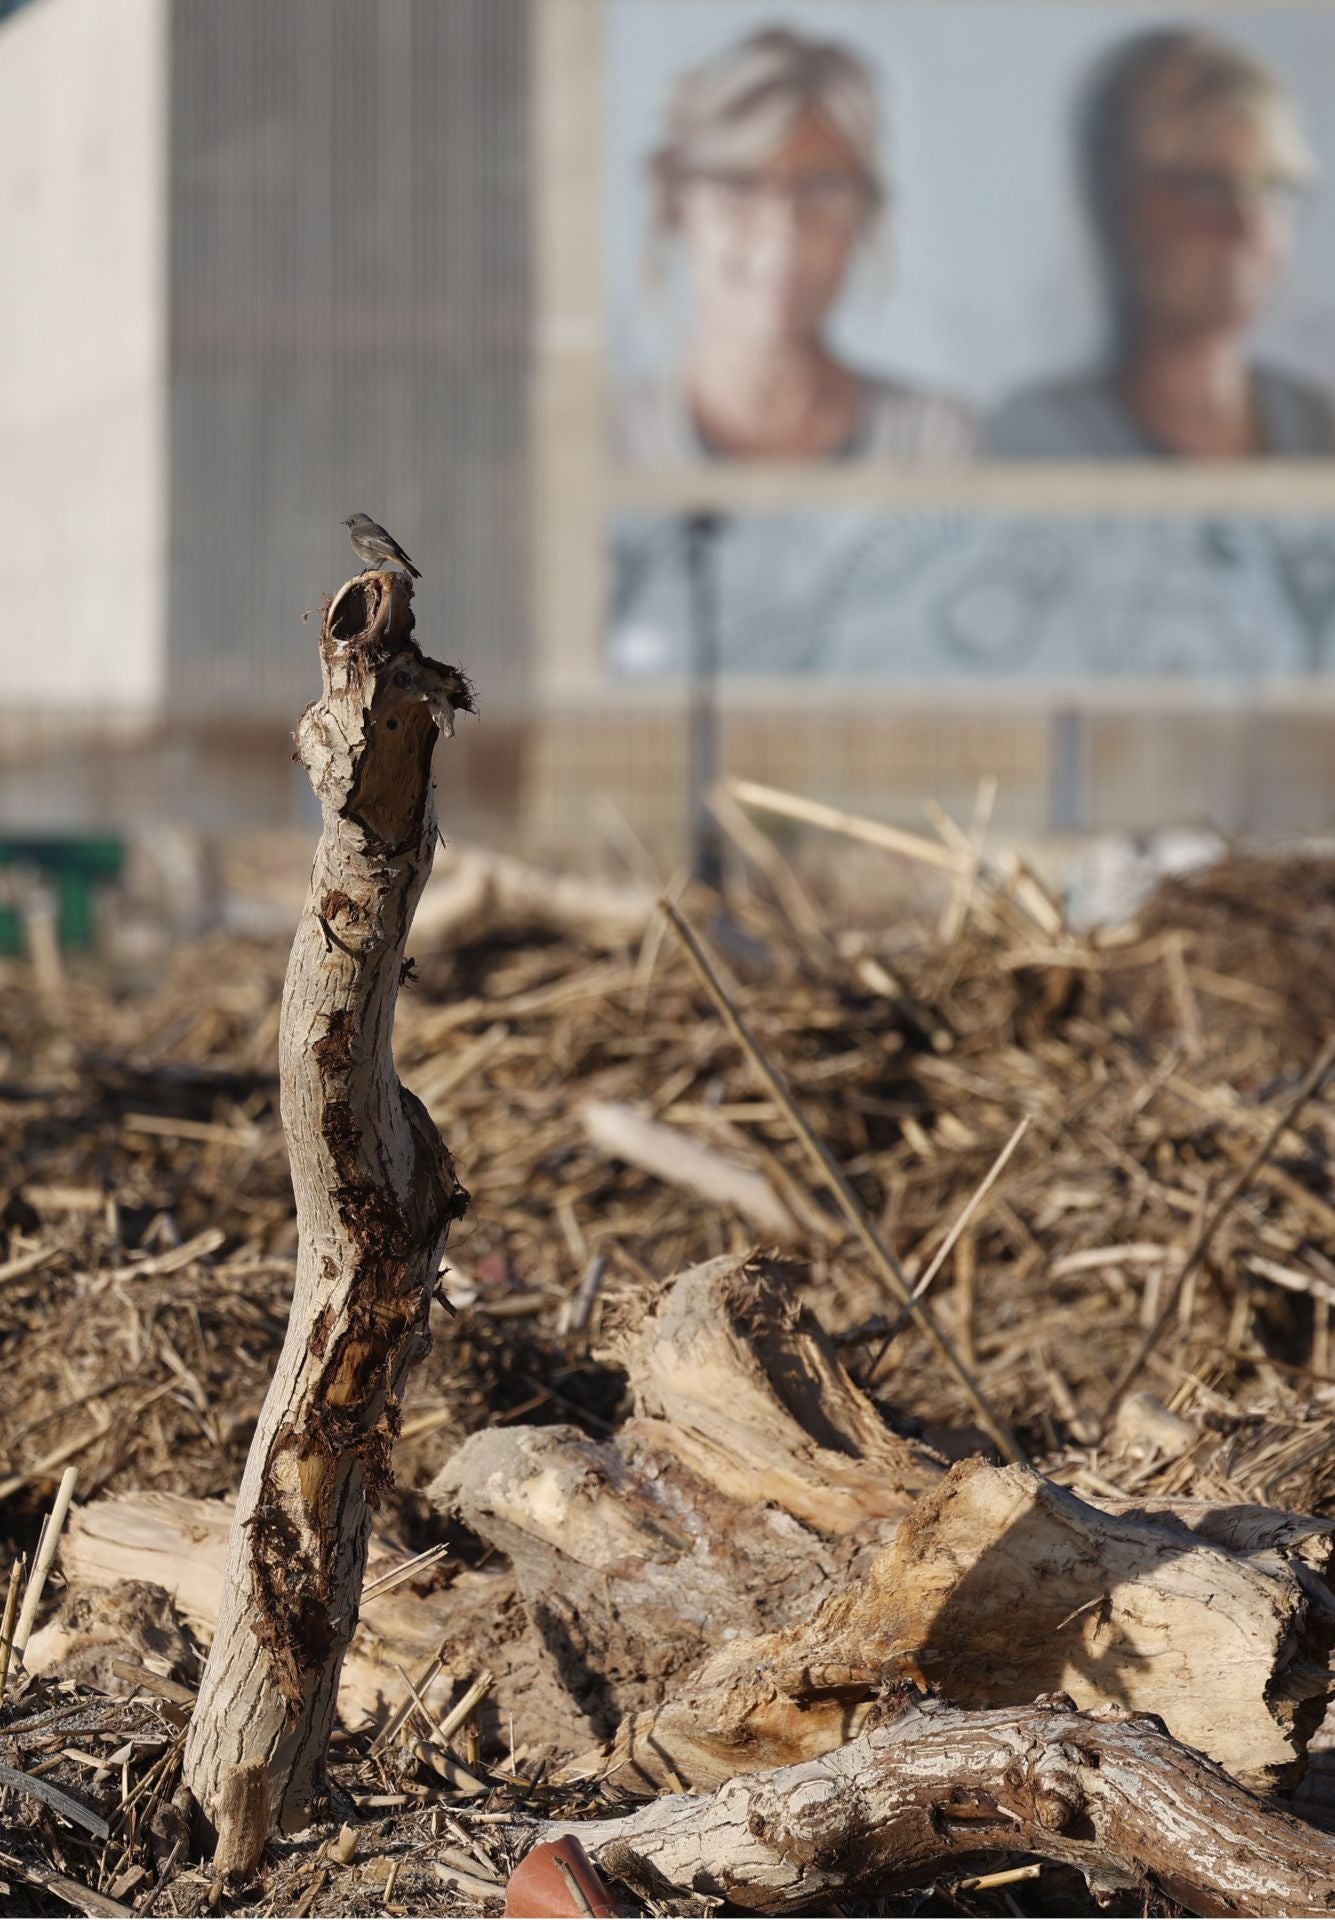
[167,0,530,722]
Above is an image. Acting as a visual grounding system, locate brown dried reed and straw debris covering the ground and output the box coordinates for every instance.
[0,856,1335,1914]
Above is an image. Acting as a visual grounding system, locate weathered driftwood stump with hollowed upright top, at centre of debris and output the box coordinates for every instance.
[428,1258,945,1734]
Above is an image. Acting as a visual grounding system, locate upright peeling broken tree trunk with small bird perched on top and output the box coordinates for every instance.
[184,572,473,1832]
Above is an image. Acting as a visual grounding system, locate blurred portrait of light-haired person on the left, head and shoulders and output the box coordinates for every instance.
[613,27,974,467]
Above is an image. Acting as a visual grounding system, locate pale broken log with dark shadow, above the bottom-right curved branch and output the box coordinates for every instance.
[587,1459,1335,1791]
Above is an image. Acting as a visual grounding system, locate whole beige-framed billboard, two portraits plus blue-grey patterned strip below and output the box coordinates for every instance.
[540,0,1335,756]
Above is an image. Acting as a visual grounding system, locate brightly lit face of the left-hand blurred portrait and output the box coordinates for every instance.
[680,111,872,346]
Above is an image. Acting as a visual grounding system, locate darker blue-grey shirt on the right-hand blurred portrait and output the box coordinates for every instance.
[982,367,1335,461]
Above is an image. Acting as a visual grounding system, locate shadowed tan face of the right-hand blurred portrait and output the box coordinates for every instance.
[1126,109,1295,336]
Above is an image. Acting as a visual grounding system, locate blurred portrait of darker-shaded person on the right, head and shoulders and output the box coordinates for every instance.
[987,29,1335,461]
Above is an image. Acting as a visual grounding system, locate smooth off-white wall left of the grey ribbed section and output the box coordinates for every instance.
[0,0,167,724]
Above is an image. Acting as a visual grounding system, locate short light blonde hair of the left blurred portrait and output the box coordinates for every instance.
[649,27,884,236]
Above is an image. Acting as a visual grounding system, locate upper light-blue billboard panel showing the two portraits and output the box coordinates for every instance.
[603,0,1335,470]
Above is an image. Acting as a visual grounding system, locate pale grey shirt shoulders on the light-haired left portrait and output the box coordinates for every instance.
[611,376,976,467]
